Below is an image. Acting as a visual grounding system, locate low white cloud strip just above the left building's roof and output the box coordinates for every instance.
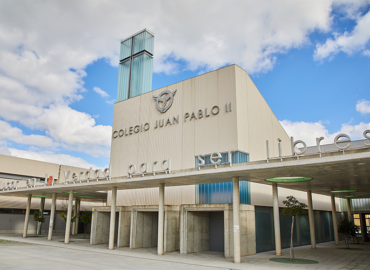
[9,148,100,169]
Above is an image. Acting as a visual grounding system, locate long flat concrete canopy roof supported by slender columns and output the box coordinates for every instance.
[0,147,370,201]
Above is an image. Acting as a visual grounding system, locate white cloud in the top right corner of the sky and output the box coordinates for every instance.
[314,1,370,60]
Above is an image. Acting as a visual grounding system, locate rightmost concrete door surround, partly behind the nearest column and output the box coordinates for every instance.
[180,204,256,258]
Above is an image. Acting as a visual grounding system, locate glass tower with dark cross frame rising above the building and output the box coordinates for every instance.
[117,29,154,102]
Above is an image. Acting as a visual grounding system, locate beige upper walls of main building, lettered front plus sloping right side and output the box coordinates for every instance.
[111,65,290,174]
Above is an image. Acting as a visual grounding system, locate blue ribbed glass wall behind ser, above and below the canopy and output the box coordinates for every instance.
[195,151,250,204]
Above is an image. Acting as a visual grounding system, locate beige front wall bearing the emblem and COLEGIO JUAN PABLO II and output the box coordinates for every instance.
[111,66,237,177]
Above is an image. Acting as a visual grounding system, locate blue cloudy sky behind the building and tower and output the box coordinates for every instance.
[0,0,370,167]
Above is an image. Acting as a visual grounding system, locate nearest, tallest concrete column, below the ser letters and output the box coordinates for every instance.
[233,176,240,263]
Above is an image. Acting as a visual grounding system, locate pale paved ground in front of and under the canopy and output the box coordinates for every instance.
[0,235,370,270]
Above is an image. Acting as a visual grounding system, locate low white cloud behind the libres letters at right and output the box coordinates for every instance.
[280,120,370,146]
